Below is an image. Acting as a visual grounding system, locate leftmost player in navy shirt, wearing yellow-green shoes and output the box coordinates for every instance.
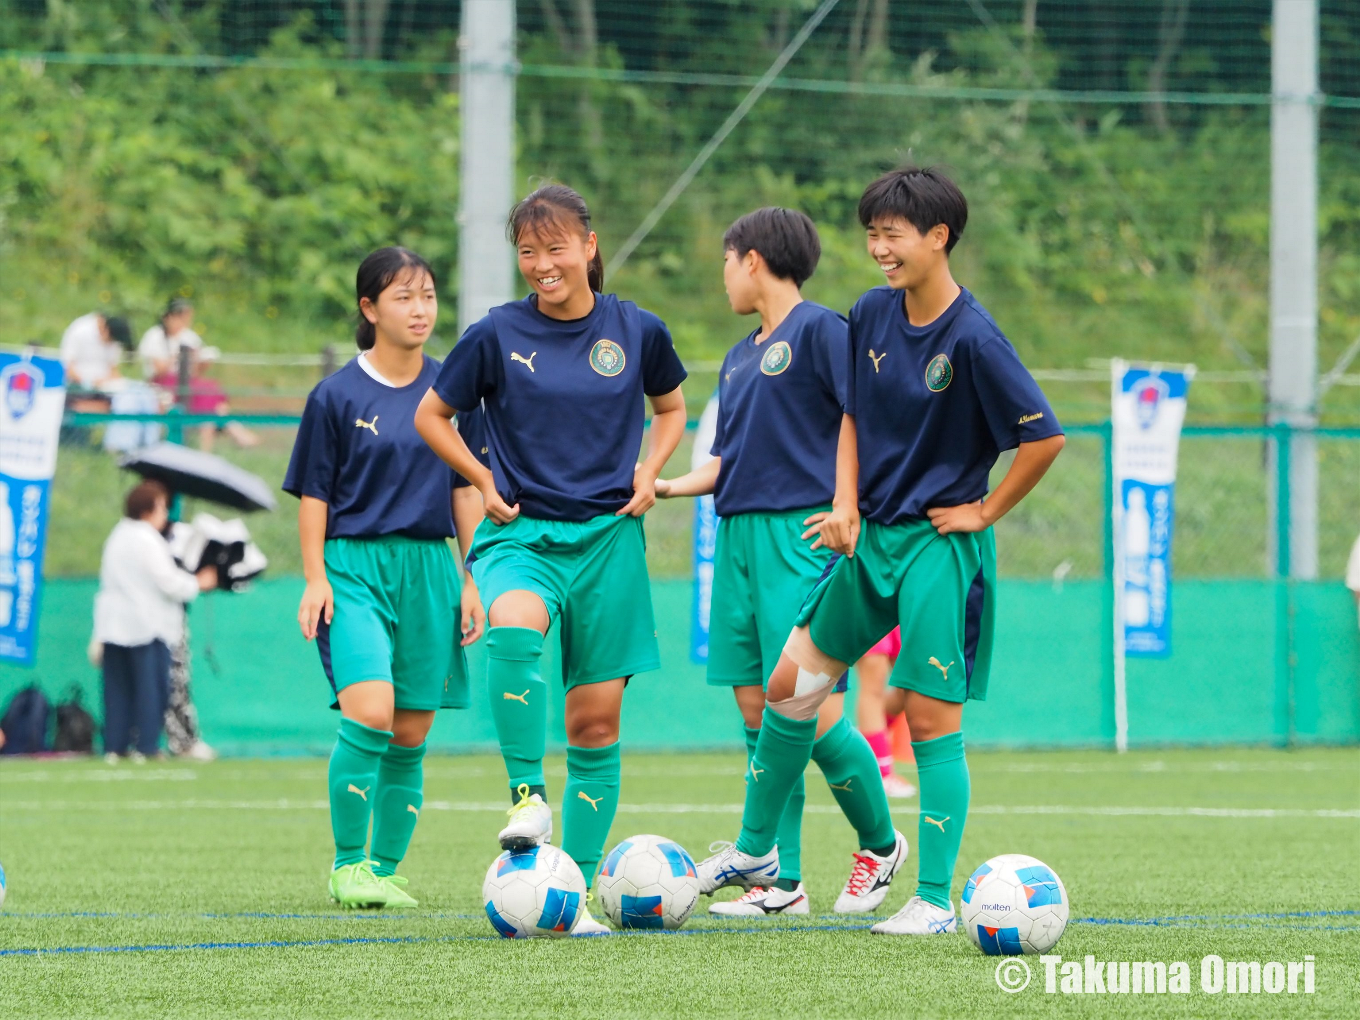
[283,248,484,908]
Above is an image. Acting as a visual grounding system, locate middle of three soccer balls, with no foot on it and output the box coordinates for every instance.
[596,836,699,929]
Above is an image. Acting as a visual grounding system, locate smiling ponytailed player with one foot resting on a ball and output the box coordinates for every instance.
[416,185,685,934]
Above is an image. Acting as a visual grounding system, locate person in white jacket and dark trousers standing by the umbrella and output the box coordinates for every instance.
[94,481,218,760]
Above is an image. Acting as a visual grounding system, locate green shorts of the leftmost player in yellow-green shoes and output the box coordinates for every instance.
[317,534,471,711]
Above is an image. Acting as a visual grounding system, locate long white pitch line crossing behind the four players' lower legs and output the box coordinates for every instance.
[4,798,1360,819]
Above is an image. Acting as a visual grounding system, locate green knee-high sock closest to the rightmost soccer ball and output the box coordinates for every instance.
[911,733,971,908]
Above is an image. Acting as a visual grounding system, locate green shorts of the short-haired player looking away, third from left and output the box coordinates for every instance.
[709,506,843,690]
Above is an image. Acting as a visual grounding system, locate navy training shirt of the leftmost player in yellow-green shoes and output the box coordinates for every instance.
[283,355,484,539]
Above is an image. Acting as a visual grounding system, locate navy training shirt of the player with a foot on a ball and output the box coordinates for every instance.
[434,294,685,521]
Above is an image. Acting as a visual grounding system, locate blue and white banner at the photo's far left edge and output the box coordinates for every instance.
[0,354,65,666]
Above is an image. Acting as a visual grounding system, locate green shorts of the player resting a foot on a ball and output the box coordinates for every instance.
[468,514,661,690]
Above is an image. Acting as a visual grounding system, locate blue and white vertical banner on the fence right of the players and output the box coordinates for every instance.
[1112,362,1194,658]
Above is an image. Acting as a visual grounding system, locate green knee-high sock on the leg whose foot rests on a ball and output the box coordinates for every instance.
[487,627,548,790]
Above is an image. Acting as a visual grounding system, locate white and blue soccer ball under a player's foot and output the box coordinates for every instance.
[481,845,586,938]
